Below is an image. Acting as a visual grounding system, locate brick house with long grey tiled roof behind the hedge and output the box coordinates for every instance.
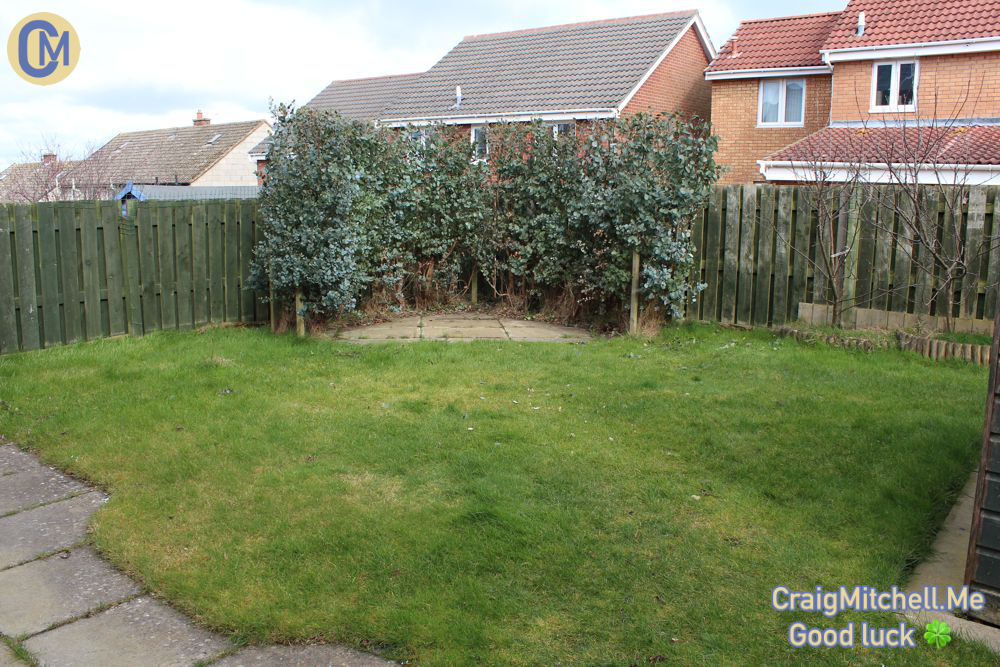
[253,10,715,175]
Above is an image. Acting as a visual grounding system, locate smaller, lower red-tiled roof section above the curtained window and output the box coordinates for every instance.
[705,12,840,72]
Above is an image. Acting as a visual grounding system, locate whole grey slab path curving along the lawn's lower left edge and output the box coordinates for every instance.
[0,443,393,667]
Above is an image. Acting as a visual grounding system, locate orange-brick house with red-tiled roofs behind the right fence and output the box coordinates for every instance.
[705,0,1000,185]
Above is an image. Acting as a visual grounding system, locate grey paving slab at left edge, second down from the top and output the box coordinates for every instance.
[0,491,107,569]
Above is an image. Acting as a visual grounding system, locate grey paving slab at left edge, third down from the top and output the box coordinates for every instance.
[0,547,141,637]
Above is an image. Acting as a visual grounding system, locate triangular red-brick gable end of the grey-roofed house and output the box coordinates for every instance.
[623,26,712,120]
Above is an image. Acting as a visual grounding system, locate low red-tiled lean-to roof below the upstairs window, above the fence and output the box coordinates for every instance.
[765,125,1000,165]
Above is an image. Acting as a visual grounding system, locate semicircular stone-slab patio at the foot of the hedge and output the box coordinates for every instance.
[337,313,591,343]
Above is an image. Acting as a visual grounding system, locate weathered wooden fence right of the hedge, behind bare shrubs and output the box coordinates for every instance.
[688,185,1000,331]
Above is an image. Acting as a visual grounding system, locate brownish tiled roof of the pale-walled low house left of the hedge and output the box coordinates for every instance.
[89,120,264,184]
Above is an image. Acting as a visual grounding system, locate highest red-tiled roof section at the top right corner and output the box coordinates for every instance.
[822,0,1000,50]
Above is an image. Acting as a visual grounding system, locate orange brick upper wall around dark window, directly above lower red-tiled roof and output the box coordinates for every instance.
[832,53,1000,122]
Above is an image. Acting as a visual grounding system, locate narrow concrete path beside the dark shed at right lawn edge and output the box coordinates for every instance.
[906,472,1000,653]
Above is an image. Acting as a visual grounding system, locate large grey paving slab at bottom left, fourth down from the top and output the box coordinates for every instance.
[24,596,232,667]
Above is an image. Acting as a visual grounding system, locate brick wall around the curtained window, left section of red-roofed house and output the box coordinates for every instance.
[712,74,830,183]
